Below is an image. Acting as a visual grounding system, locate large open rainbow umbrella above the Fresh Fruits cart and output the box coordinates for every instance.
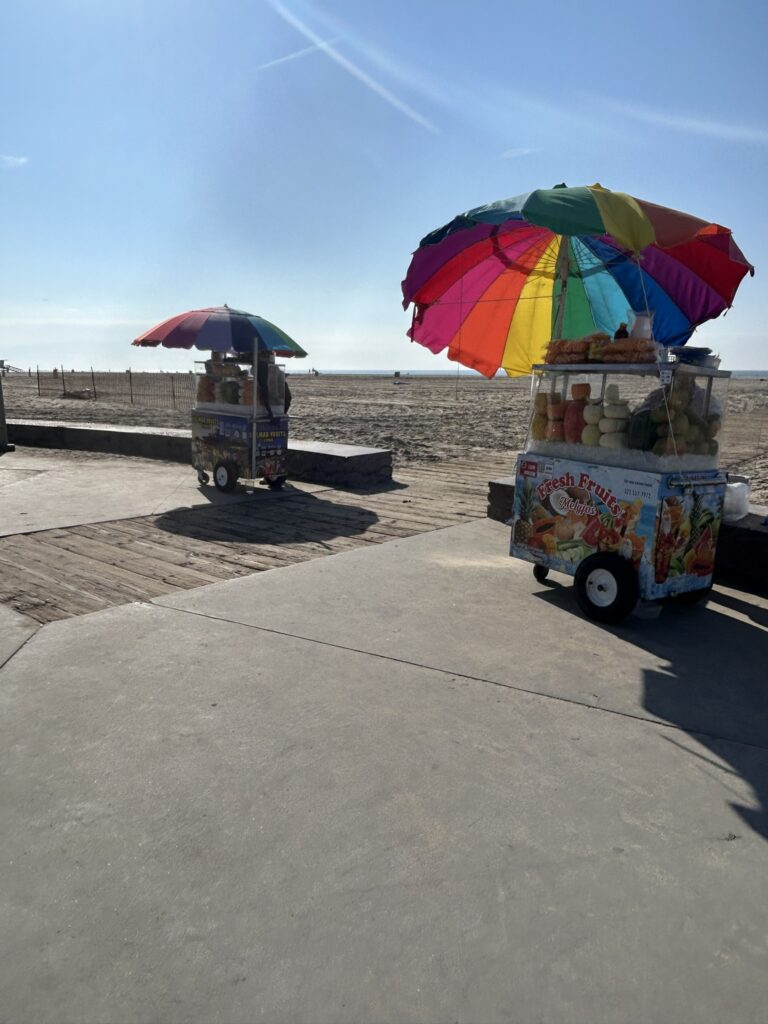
[402,184,755,377]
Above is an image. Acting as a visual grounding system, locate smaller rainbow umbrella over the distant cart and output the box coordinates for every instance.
[133,305,306,357]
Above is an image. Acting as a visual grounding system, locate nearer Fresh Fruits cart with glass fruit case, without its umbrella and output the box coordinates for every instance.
[510,339,730,623]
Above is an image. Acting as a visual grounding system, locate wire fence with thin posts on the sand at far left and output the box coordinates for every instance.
[3,368,196,411]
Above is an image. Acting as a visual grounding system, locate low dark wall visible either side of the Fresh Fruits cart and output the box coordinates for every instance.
[487,476,768,594]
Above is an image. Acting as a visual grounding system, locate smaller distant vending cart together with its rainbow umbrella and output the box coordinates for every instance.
[133,305,306,490]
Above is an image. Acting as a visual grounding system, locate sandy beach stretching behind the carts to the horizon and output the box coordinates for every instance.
[3,374,768,504]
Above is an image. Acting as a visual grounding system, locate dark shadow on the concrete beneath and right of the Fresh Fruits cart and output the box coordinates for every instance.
[537,580,768,839]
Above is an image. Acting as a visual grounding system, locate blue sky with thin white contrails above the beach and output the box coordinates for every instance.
[0,0,768,370]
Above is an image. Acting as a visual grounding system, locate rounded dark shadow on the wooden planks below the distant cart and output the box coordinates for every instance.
[155,490,379,547]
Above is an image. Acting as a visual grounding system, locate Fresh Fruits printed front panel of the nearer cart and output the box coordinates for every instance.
[510,455,658,584]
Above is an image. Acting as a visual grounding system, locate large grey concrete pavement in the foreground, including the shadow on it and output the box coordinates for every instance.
[0,521,768,1024]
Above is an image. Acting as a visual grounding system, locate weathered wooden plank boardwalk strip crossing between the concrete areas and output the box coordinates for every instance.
[0,458,489,623]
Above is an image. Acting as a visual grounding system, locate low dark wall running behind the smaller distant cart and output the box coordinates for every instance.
[8,420,392,487]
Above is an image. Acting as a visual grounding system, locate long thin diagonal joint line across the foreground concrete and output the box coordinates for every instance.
[154,602,768,753]
